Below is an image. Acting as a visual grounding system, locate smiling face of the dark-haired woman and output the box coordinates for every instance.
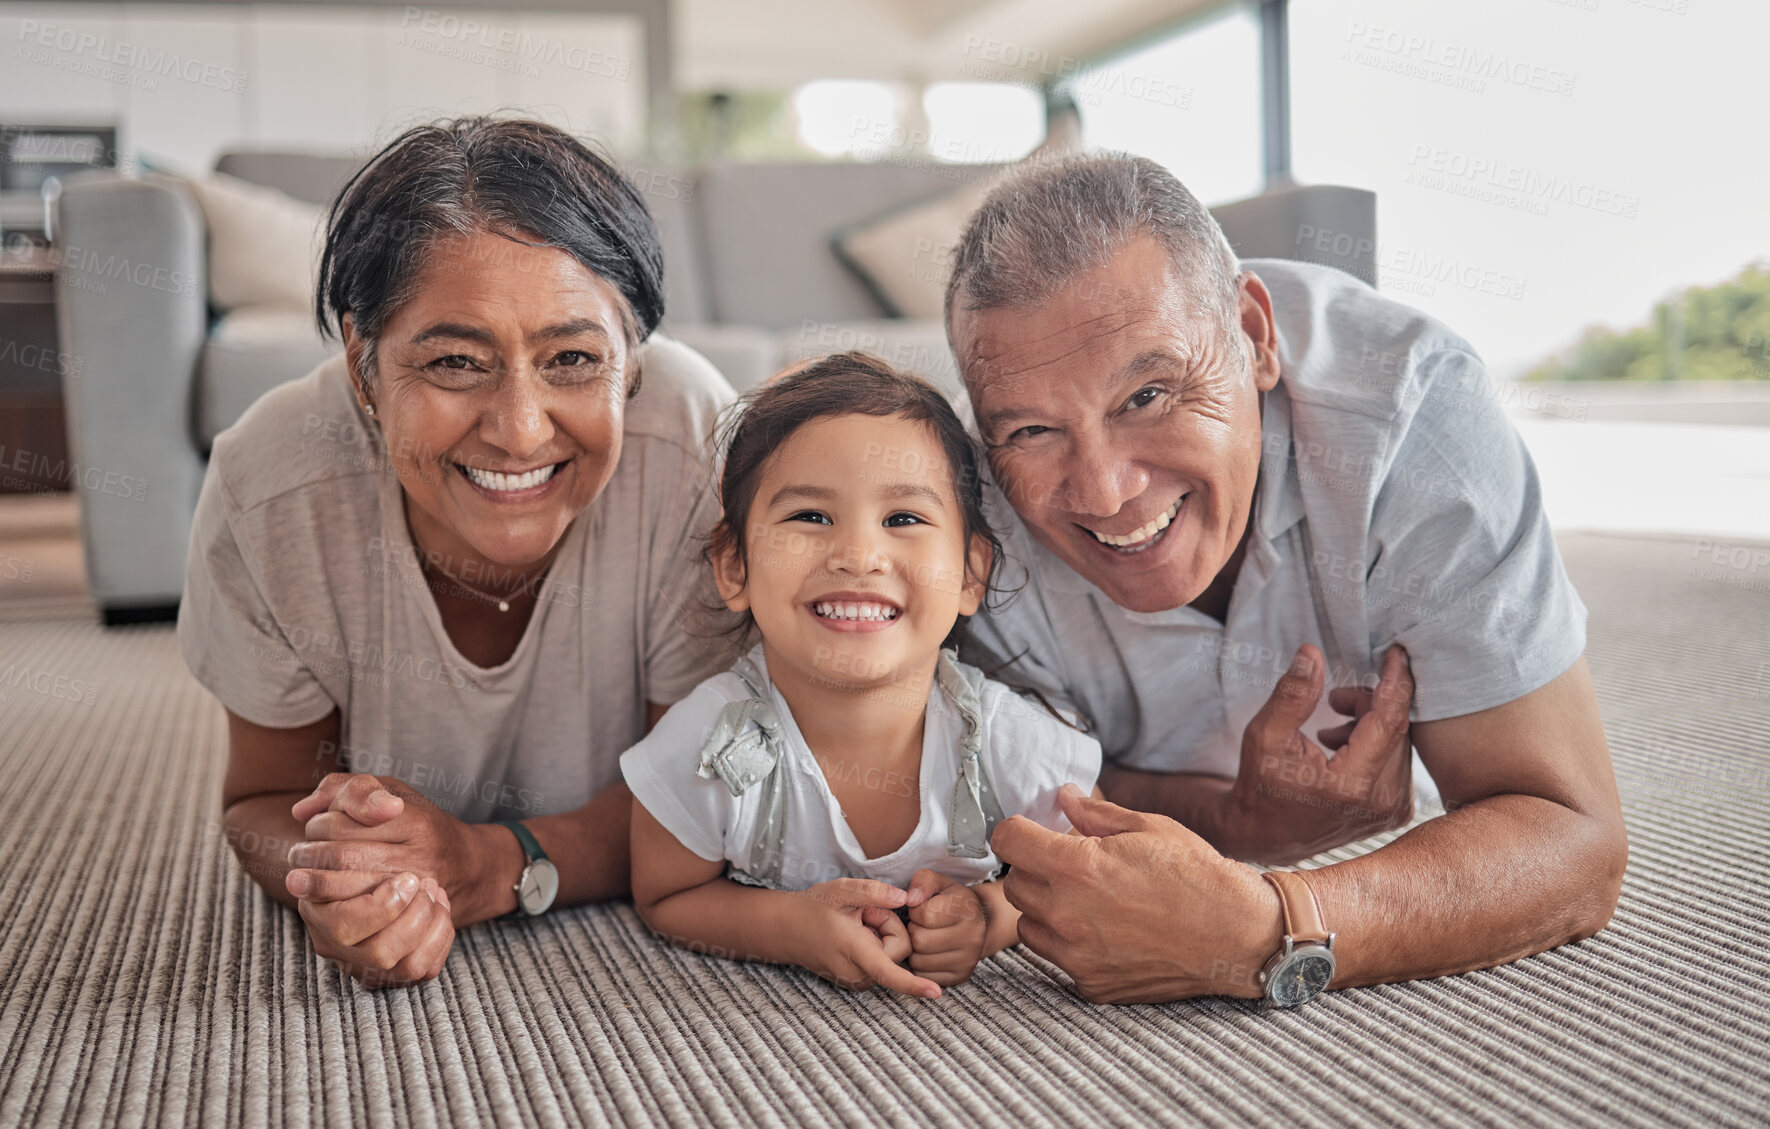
[359,232,634,568]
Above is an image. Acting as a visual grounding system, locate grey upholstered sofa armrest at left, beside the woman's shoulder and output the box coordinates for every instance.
[57,172,207,619]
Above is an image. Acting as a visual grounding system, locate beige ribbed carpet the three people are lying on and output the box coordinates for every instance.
[0,536,1770,1129]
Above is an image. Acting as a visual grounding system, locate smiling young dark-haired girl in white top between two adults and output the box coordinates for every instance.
[621,354,1101,998]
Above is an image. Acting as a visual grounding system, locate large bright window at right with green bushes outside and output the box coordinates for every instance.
[1290,0,1770,380]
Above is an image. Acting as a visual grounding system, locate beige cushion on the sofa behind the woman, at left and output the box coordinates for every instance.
[196,306,340,449]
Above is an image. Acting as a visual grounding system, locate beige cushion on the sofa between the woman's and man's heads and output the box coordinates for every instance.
[699,161,1012,331]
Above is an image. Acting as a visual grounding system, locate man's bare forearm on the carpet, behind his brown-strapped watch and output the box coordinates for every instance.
[1239,795,1627,987]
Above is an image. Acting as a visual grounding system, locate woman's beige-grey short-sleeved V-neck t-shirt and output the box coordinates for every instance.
[179,338,735,823]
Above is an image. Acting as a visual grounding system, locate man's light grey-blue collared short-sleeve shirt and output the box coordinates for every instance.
[972,260,1586,777]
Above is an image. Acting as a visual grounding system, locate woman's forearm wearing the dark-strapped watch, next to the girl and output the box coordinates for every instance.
[463,780,634,925]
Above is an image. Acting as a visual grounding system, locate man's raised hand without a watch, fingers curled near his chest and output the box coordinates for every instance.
[1223,644,1414,862]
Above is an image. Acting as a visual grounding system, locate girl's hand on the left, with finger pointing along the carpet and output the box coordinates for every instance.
[795,878,940,1000]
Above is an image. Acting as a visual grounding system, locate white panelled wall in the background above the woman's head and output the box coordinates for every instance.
[0,2,646,172]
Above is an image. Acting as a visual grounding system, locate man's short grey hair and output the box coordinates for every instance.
[947,152,1241,357]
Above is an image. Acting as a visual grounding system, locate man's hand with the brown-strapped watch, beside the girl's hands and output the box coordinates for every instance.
[991,786,1283,1003]
